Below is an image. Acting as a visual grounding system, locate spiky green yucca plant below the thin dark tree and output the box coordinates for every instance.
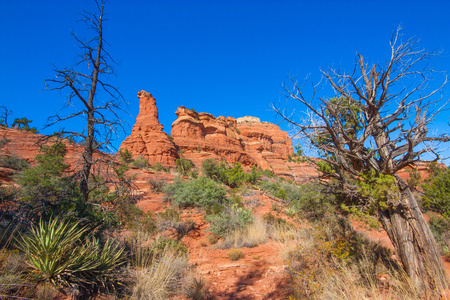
[18,218,125,289]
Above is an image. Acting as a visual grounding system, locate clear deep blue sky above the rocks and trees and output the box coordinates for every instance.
[0,0,450,159]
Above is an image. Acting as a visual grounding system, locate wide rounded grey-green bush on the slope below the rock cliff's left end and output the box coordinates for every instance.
[164,176,228,208]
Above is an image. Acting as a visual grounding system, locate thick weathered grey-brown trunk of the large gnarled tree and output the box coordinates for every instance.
[379,177,450,291]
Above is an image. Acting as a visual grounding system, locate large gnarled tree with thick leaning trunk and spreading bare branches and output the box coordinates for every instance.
[273,28,450,290]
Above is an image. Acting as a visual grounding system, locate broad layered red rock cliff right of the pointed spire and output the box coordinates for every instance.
[171,107,293,176]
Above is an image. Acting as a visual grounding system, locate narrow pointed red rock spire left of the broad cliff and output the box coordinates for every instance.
[119,91,178,166]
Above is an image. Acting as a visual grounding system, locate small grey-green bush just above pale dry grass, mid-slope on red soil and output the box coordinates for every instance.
[206,205,253,237]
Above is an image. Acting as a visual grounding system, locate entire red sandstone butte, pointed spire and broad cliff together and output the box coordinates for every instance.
[120,91,293,176]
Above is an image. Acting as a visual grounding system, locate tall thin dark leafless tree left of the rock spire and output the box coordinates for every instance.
[46,0,124,201]
